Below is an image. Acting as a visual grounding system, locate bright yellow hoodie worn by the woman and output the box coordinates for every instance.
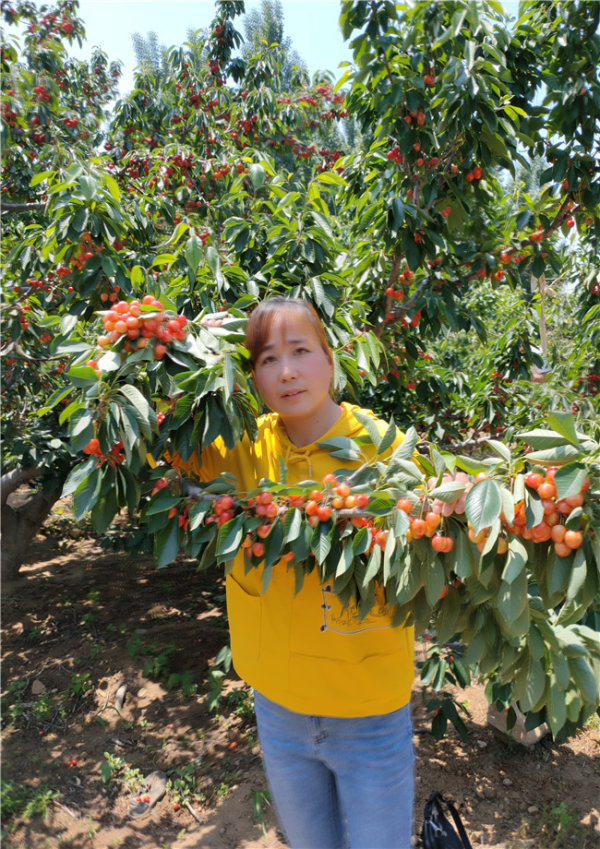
[173,403,414,717]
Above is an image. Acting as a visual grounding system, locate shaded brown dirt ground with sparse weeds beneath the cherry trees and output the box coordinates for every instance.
[2,504,600,849]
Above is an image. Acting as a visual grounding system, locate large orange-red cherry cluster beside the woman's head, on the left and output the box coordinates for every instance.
[98,295,187,360]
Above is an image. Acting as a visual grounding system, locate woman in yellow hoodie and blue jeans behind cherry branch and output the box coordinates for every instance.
[170,298,414,849]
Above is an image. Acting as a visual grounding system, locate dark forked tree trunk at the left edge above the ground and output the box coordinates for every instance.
[0,469,62,583]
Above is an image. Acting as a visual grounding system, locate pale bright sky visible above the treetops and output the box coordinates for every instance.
[70,0,352,94]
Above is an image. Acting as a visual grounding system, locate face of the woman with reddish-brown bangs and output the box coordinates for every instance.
[254,313,337,432]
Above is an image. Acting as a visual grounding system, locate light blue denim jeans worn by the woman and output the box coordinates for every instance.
[254,692,414,849]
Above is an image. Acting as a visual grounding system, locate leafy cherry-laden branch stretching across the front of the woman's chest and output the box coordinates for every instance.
[144,400,600,735]
